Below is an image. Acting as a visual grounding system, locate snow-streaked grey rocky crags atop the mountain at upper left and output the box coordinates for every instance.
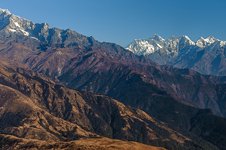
[0,9,95,50]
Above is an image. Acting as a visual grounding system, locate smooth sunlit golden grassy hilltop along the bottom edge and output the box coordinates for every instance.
[0,135,164,150]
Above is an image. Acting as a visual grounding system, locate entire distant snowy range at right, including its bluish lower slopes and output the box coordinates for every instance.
[127,35,226,76]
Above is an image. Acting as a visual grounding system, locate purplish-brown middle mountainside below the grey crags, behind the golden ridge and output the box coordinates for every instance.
[0,25,225,119]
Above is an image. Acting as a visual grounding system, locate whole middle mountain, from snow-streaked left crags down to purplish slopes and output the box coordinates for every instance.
[0,9,226,119]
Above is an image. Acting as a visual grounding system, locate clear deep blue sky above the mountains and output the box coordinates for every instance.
[0,0,226,46]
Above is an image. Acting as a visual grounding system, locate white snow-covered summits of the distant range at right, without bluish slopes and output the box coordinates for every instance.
[127,34,226,56]
